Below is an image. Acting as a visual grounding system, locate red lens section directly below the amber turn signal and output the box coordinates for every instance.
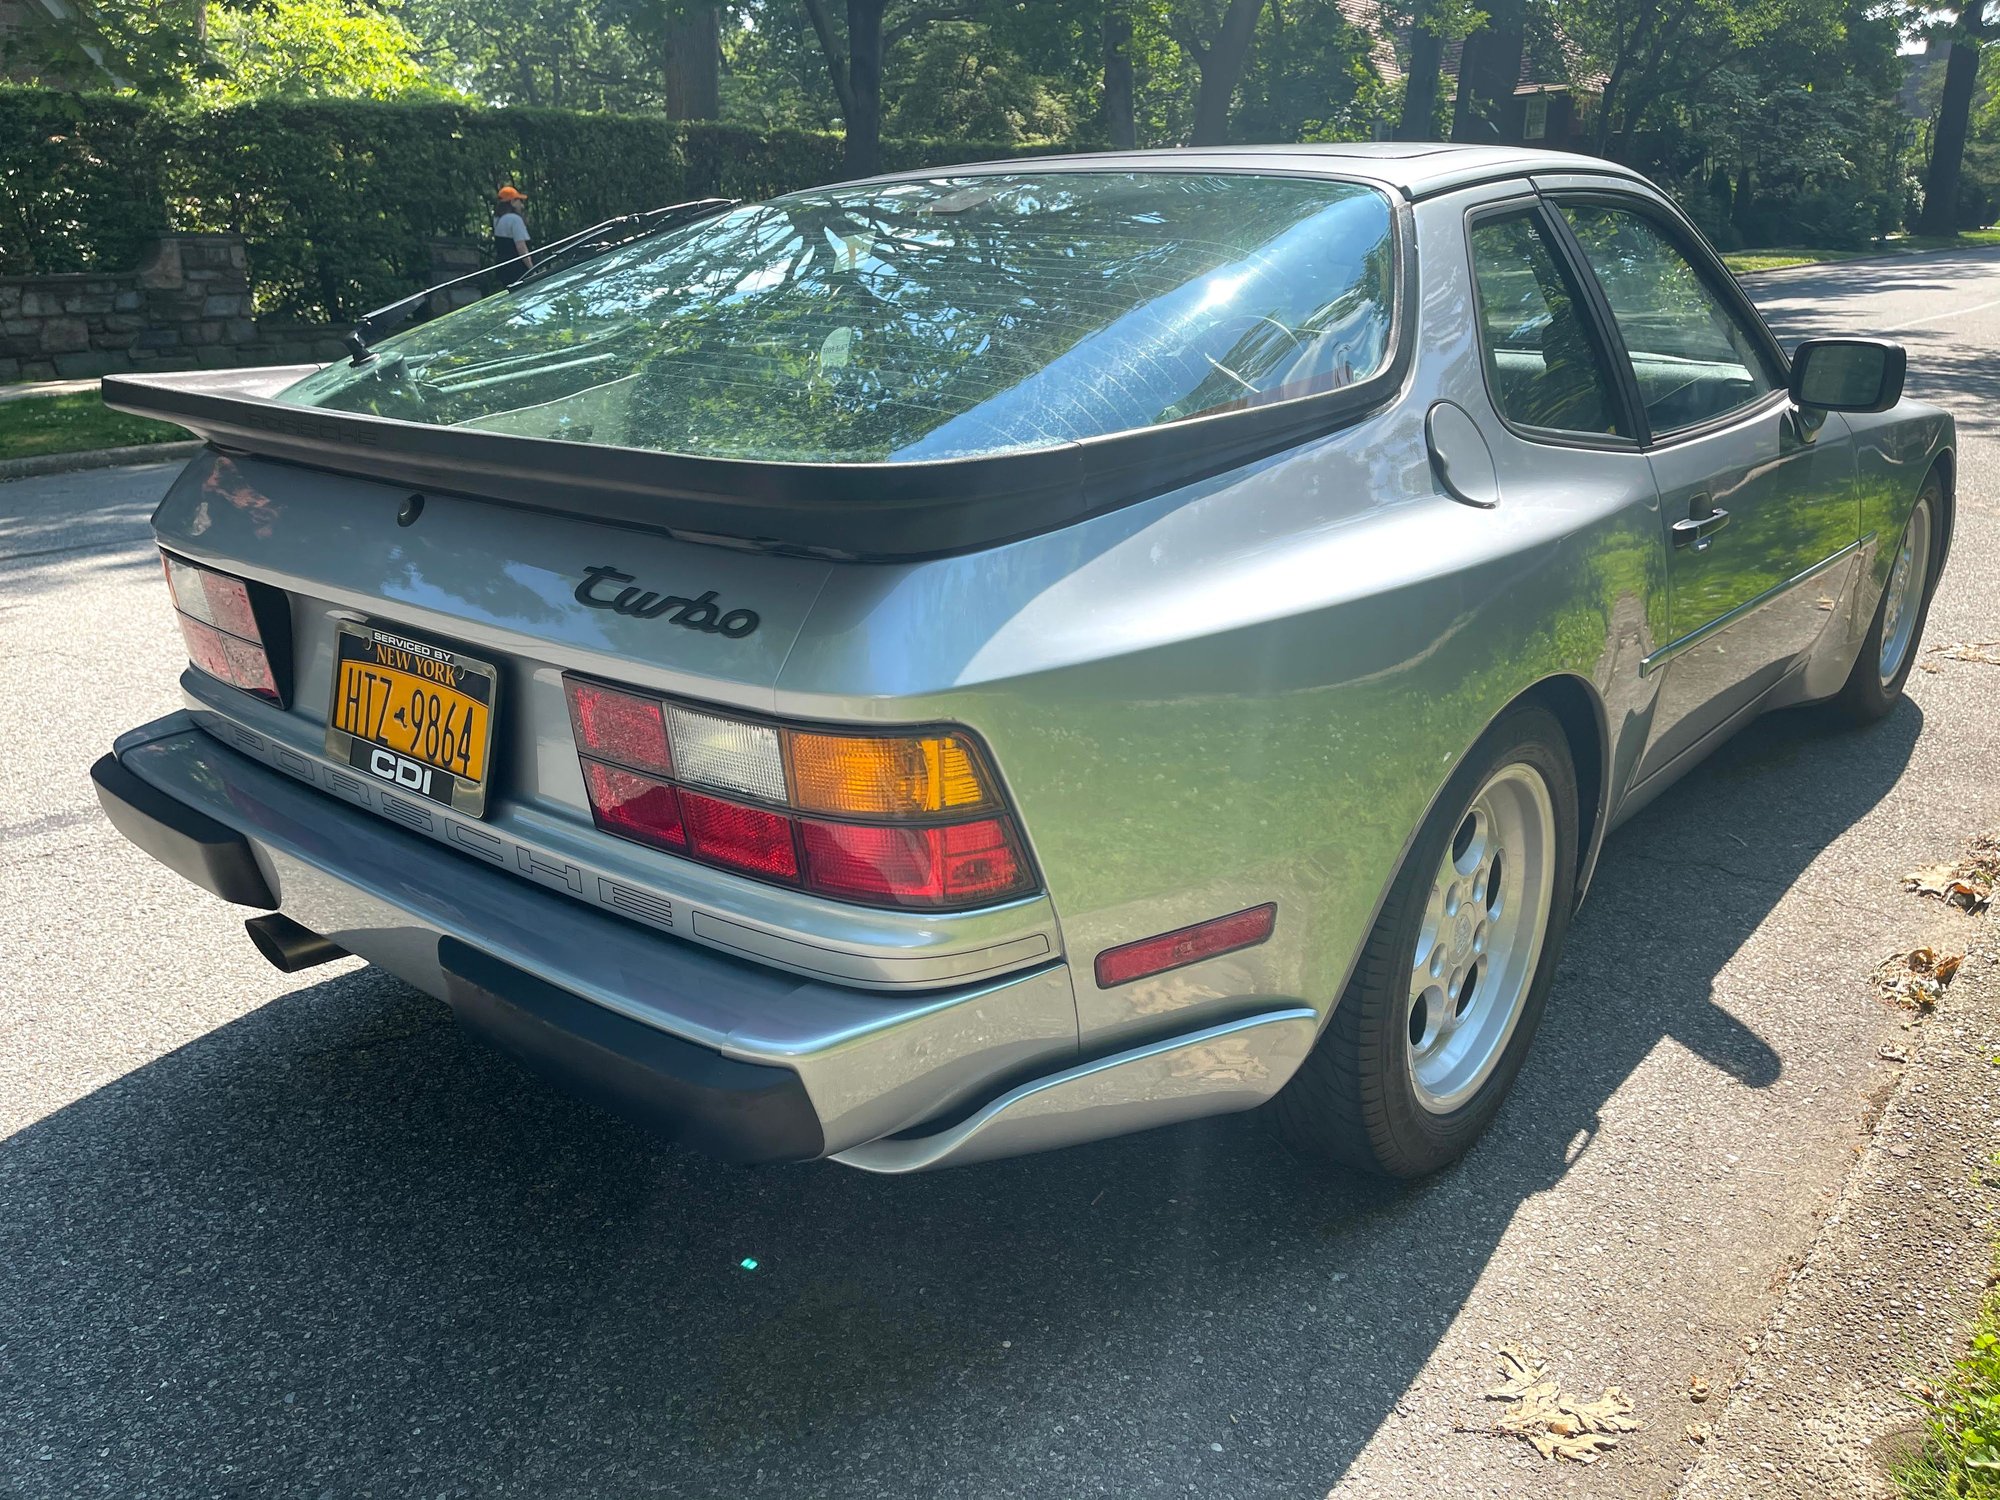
[800,818,1030,906]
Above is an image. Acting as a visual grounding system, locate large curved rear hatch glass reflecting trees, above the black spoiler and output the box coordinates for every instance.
[278,172,1394,462]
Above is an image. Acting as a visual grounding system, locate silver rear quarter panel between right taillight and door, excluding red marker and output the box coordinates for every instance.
[776,188,1664,1048]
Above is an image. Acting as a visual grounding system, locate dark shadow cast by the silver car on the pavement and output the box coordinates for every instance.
[0,704,1922,1500]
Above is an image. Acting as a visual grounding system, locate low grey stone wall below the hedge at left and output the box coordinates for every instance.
[0,234,492,382]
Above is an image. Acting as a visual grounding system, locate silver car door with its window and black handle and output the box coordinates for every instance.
[1554,190,1860,778]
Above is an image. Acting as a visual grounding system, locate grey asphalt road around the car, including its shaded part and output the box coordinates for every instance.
[0,254,2000,1500]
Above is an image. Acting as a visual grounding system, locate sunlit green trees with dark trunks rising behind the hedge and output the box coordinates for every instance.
[3,0,2000,256]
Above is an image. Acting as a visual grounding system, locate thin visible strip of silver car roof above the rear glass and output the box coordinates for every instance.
[852,140,1644,200]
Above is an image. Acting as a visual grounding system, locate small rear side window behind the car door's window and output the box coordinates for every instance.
[1472,210,1618,434]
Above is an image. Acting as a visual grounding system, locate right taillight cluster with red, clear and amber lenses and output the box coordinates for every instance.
[564,678,1034,908]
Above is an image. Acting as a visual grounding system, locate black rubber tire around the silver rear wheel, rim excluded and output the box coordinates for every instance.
[1272,706,1580,1178]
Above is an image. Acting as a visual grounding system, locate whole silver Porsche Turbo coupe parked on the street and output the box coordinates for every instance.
[94,146,1954,1174]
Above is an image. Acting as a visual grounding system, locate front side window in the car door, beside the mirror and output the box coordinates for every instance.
[1562,204,1784,434]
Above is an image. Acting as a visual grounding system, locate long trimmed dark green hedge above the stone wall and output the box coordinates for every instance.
[0,88,1080,322]
